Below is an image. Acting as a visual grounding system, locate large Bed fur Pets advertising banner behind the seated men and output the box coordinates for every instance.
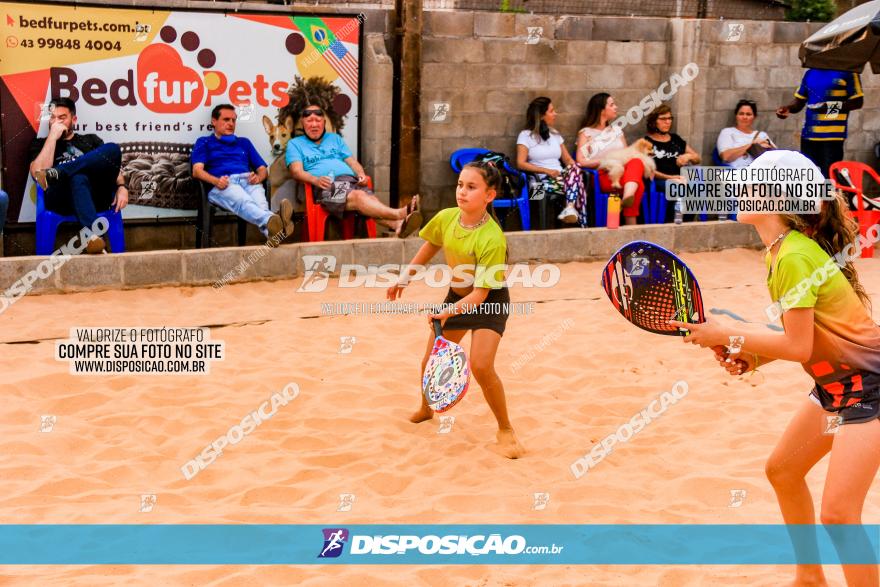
[0,2,363,222]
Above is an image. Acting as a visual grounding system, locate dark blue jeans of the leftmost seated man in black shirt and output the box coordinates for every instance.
[46,143,122,227]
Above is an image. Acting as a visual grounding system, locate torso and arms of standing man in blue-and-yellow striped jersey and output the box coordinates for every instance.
[776,69,864,177]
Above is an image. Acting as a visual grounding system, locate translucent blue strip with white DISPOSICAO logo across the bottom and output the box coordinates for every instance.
[0,524,880,565]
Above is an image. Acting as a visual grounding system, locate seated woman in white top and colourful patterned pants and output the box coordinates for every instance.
[516,96,587,227]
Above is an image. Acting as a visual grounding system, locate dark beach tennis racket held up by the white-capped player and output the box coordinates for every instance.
[602,241,706,336]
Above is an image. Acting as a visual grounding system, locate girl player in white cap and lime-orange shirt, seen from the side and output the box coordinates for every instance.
[672,151,880,586]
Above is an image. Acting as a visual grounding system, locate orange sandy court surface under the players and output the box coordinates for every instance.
[0,250,880,586]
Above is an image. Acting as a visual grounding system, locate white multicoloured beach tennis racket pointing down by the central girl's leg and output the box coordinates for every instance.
[422,320,471,412]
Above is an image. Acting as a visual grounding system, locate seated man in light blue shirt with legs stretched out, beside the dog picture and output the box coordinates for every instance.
[285,104,422,238]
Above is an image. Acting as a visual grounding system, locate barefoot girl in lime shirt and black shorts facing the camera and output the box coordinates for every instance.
[388,163,524,459]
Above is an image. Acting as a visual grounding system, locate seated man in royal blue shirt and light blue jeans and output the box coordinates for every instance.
[192,104,293,246]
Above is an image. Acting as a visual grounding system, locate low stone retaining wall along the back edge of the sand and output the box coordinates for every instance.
[0,222,760,296]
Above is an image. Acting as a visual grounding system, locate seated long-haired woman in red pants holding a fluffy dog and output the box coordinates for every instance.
[577,92,645,224]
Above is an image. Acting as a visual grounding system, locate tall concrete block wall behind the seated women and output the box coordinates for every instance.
[421,10,880,216]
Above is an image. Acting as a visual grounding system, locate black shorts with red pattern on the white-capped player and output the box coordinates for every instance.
[810,372,880,424]
